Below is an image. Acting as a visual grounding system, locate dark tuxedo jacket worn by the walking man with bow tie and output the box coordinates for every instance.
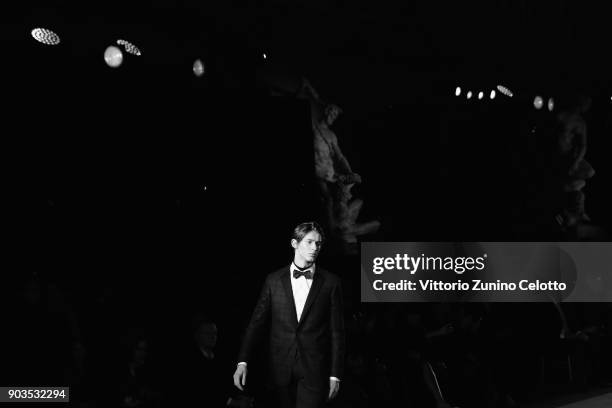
[238,266,345,387]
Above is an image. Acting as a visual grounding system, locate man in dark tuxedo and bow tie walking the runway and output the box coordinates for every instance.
[234,222,345,408]
